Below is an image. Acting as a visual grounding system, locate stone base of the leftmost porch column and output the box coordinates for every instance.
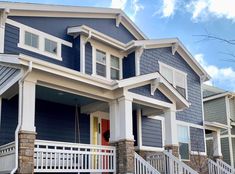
[17,131,36,174]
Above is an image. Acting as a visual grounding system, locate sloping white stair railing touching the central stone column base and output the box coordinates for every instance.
[135,153,160,174]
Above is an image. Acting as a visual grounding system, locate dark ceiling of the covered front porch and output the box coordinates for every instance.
[36,86,102,106]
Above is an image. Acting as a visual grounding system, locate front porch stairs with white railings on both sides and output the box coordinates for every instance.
[135,151,198,174]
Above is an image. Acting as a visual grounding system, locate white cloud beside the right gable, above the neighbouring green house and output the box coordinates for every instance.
[194,54,235,91]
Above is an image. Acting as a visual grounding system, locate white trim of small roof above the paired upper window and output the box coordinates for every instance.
[67,25,134,51]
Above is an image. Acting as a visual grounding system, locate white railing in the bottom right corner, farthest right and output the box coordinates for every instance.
[208,159,235,174]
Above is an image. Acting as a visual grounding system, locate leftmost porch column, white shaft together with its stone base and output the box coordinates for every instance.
[17,80,36,174]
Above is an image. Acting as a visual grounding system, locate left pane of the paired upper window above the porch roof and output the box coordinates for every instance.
[96,50,106,77]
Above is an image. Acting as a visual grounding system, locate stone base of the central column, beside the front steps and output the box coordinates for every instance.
[110,140,135,173]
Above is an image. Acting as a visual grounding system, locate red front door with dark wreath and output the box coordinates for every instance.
[101,119,110,146]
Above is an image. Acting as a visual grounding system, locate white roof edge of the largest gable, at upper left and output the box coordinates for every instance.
[0,1,147,40]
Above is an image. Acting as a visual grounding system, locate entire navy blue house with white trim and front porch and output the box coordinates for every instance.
[0,2,209,173]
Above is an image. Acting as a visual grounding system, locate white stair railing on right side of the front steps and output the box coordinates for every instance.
[147,151,198,174]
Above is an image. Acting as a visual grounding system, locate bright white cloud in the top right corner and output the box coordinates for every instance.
[186,0,235,20]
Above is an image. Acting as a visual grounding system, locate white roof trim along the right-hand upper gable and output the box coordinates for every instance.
[135,38,210,81]
